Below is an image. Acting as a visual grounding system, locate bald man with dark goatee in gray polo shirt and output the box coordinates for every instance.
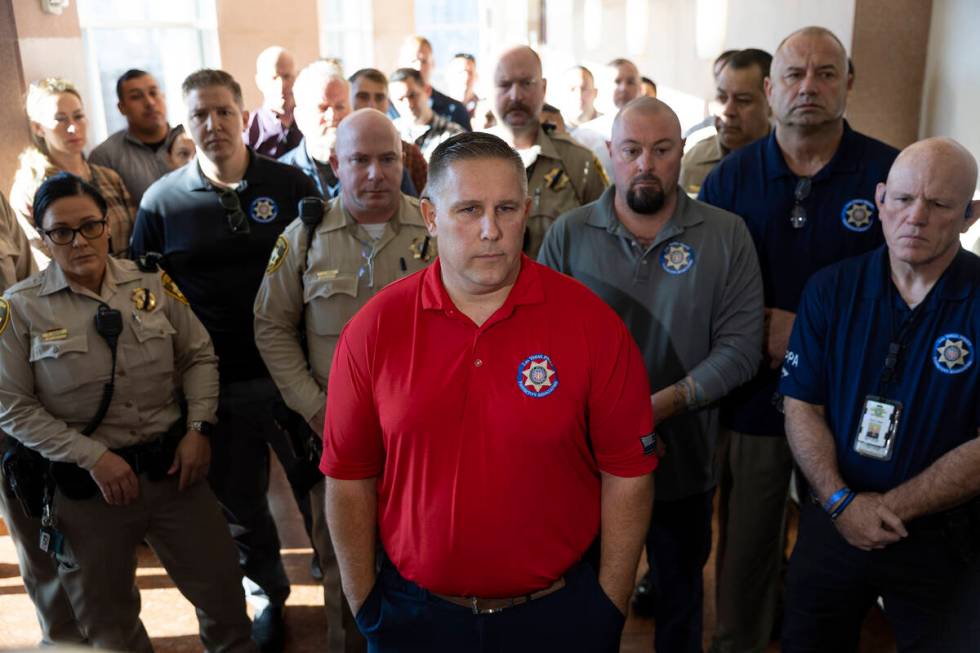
[538,97,763,652]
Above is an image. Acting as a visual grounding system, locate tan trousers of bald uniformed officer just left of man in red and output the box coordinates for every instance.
[310,480,367,653]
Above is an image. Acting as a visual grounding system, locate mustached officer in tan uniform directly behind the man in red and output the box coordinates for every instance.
[487,46,609,256]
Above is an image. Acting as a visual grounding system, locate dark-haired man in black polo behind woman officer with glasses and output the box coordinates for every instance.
[131,70,318,653]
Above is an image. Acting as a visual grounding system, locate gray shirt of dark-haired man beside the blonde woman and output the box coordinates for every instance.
[88,125,184,206]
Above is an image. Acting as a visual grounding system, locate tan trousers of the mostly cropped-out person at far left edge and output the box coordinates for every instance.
[0,473,85,645]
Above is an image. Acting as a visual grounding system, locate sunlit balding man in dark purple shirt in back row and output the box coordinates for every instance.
[245,45,303,159]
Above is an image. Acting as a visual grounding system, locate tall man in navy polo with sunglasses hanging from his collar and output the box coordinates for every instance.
[699,27,897,653]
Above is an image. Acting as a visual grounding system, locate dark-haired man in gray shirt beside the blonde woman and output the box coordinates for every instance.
[88,68,184,206]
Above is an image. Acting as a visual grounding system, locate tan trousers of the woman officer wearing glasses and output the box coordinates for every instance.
[54,474,256,653]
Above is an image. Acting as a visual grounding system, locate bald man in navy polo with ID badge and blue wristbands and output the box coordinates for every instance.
[780,138,980,651]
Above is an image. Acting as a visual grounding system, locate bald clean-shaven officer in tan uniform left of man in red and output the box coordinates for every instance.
[254,109,436,653]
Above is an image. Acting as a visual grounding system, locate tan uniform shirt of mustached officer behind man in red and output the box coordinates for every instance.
[488,127,609,258]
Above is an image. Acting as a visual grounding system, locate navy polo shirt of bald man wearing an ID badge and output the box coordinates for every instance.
[780,247,980,492]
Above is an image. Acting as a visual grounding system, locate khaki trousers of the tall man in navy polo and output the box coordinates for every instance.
[711,431,793,653]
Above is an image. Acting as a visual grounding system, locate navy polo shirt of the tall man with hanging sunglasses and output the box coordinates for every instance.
[698,121,898,435]
